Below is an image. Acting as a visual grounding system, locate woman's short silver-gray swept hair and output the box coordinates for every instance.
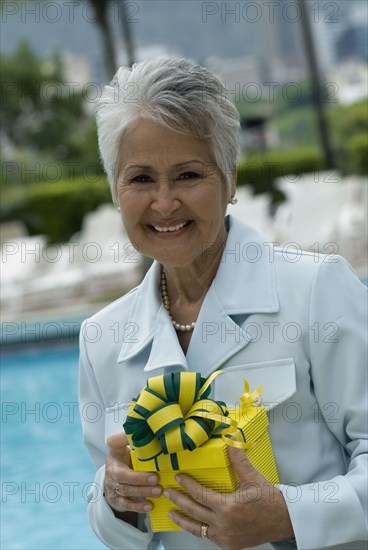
[97,56,240,204]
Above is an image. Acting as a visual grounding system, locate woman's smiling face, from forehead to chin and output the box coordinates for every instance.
[117,119,234,267]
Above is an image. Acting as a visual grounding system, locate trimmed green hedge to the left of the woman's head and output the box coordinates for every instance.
[1,176,111,243]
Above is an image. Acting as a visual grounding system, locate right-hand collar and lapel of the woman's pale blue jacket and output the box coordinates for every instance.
[187,216,279,376]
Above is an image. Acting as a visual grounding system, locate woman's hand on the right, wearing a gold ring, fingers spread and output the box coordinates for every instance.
[164,447,294,550]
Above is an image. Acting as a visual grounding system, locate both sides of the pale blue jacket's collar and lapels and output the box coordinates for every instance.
[118,216,279,375]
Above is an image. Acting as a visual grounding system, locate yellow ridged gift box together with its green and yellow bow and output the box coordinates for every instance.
[123,371,278,532]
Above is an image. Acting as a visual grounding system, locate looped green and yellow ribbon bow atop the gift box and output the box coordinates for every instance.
[123,371,262,461]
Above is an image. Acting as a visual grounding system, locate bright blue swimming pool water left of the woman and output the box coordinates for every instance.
[0,345,105,550]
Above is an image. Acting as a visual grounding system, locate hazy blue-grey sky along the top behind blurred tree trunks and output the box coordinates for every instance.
[0,0,367,80]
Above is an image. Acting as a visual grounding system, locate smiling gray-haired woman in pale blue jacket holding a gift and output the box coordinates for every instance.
[80,57,367,549]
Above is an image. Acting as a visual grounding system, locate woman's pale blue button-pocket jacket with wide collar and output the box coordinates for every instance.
[80,216,368,550]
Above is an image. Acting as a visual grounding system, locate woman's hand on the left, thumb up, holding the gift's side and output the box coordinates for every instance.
[105,432,162,523]
